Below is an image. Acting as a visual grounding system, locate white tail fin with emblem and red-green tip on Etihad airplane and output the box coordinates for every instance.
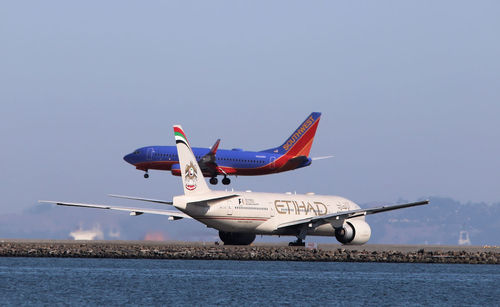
[174,125,210,195]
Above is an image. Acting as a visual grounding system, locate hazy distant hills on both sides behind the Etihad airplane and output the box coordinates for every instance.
[0,197,500,245]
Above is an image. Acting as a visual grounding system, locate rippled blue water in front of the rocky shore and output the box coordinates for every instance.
[0,258,500,306]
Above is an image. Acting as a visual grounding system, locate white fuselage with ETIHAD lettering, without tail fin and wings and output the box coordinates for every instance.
[174,191,365,236]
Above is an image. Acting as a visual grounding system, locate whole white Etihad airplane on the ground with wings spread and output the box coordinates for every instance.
[40,125,429,246]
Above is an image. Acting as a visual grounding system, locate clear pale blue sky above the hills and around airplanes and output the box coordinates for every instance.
[0,1,500,218]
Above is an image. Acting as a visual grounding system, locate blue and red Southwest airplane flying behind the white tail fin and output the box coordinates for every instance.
[123,112,330,185]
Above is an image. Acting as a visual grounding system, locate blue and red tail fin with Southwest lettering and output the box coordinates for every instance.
[263,112,321,157]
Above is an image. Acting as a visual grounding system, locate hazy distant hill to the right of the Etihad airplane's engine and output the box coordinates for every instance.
[367,197,500,245]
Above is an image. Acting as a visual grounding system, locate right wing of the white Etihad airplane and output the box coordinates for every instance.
[277,200,429,229]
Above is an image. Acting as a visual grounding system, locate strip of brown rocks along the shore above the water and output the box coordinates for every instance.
[0,240,500,264]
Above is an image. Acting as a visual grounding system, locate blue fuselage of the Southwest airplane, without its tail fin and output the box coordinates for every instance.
[123,146,311,177]
